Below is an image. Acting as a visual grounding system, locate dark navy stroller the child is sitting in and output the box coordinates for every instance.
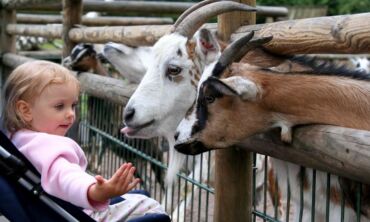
[0,131,171,222]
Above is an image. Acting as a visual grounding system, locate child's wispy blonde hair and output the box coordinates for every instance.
[1,61,80,134]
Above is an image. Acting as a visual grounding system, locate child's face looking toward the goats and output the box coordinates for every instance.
[31,83,79,136]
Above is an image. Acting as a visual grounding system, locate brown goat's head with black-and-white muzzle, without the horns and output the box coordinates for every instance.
[175,76,269,154]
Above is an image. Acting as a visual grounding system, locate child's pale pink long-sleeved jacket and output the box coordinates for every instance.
[12,130,109,210]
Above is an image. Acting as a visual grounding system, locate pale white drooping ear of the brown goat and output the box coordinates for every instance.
[220,76,259,101]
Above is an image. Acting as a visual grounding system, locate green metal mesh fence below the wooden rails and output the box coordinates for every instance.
[78,94,363,221]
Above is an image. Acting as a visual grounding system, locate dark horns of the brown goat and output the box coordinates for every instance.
[218,31,272,67]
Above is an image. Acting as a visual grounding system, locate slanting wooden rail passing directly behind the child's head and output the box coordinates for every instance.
[2,53,137,106]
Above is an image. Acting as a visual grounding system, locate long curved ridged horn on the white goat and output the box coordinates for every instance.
[174,1,257,38]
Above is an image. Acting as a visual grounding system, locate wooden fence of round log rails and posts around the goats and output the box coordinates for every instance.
[0,0,370,221]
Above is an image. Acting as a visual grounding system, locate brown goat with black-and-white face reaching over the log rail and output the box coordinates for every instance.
[175,33,370,222]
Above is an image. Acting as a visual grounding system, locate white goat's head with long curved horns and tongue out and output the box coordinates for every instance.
[121,1,255,138]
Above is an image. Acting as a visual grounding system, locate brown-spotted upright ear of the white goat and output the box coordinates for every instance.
[195,28,221,64]
